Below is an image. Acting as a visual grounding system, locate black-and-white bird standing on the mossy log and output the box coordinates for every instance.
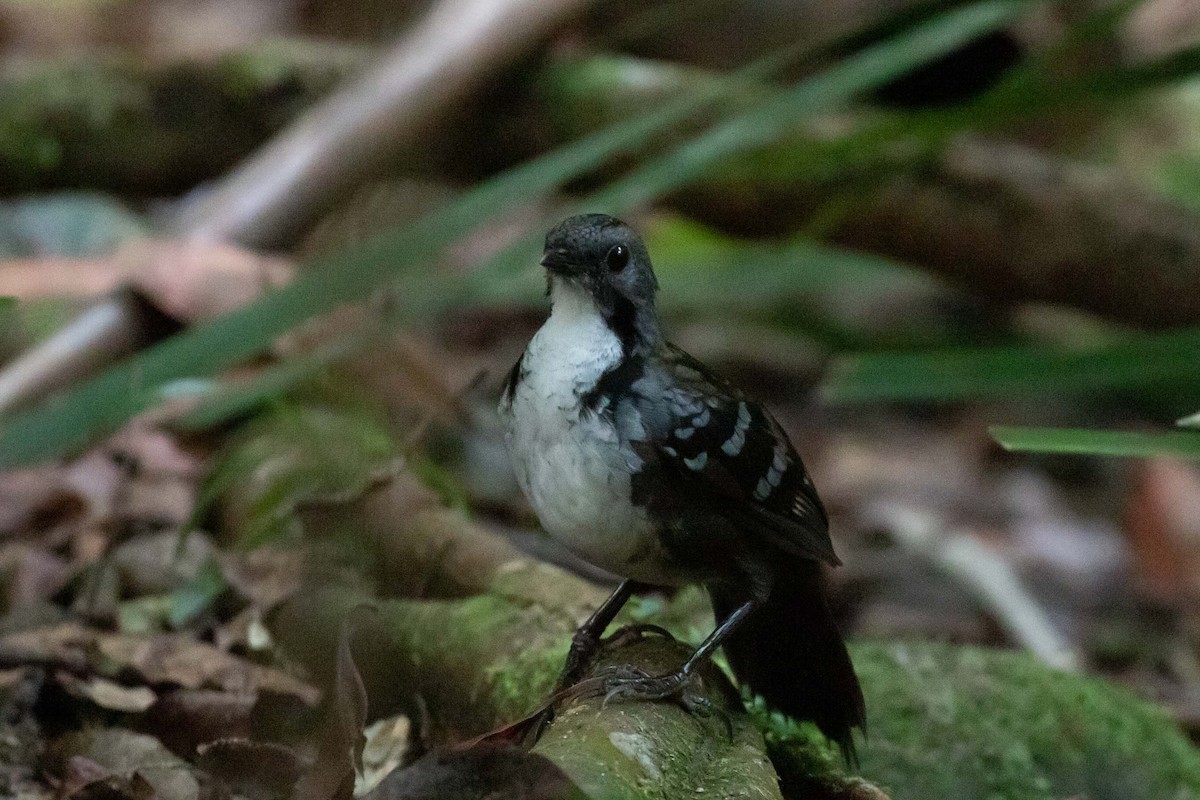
[499,213,865,764]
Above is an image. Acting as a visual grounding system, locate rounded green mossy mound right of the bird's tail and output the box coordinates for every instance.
[785,642,1200,800]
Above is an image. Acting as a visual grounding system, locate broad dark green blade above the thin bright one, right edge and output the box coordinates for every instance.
[822,329,1200,403]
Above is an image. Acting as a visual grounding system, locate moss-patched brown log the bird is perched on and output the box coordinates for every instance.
[271,473,796,800]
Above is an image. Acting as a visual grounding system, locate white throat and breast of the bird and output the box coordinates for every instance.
[500,285,665,582]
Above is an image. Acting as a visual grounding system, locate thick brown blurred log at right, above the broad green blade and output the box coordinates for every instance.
[834,137,1200,327]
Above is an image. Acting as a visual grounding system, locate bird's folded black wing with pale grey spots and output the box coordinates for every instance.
[588,347,839,565]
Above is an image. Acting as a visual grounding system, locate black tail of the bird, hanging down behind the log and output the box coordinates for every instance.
[708,559,866,765]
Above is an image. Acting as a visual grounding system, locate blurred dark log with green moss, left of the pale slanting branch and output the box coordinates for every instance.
[0,40,370,197]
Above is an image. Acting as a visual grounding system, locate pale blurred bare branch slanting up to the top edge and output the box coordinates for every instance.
[175,0,586,247]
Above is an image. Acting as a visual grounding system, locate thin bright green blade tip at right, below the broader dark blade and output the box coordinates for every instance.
[989,426,1200,458]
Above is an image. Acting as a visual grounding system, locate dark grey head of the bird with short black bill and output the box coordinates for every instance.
[541,213,659,350]
